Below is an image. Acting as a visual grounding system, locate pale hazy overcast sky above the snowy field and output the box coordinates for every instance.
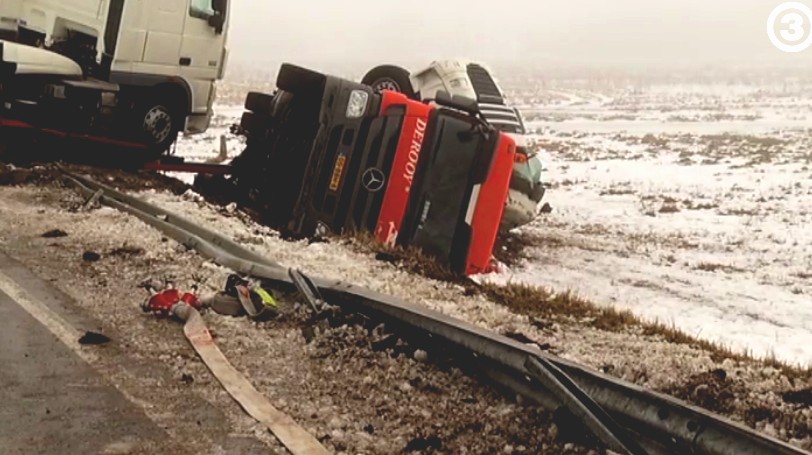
[225,0,812,72]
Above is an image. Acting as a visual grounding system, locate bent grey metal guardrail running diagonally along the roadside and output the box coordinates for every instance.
[63,170,807,455]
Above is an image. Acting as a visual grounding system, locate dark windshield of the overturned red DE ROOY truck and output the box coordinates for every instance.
[404,111,498,270]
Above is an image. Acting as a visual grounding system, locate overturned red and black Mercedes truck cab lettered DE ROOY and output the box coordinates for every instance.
[222,64,516,275]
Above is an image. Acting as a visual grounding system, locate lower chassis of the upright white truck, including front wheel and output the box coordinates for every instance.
[0,41,175,154]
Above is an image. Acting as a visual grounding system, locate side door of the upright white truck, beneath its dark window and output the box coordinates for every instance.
[180,0,228,113]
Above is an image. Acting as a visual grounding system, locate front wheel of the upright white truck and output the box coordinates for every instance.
[135,98,181,155]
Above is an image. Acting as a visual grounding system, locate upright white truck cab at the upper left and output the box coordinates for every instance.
[0,0,229,152]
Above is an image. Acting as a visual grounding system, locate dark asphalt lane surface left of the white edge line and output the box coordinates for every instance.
[0,282,164,454]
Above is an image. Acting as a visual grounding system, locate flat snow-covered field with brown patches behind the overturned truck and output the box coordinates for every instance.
[178,81,812,364]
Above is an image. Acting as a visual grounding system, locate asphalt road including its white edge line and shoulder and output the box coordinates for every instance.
[0,251,272,455]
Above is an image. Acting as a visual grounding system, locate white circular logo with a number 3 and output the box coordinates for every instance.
[767,2,812,52]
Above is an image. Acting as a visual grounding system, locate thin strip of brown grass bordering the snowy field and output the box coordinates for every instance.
[0,163,812,379]
